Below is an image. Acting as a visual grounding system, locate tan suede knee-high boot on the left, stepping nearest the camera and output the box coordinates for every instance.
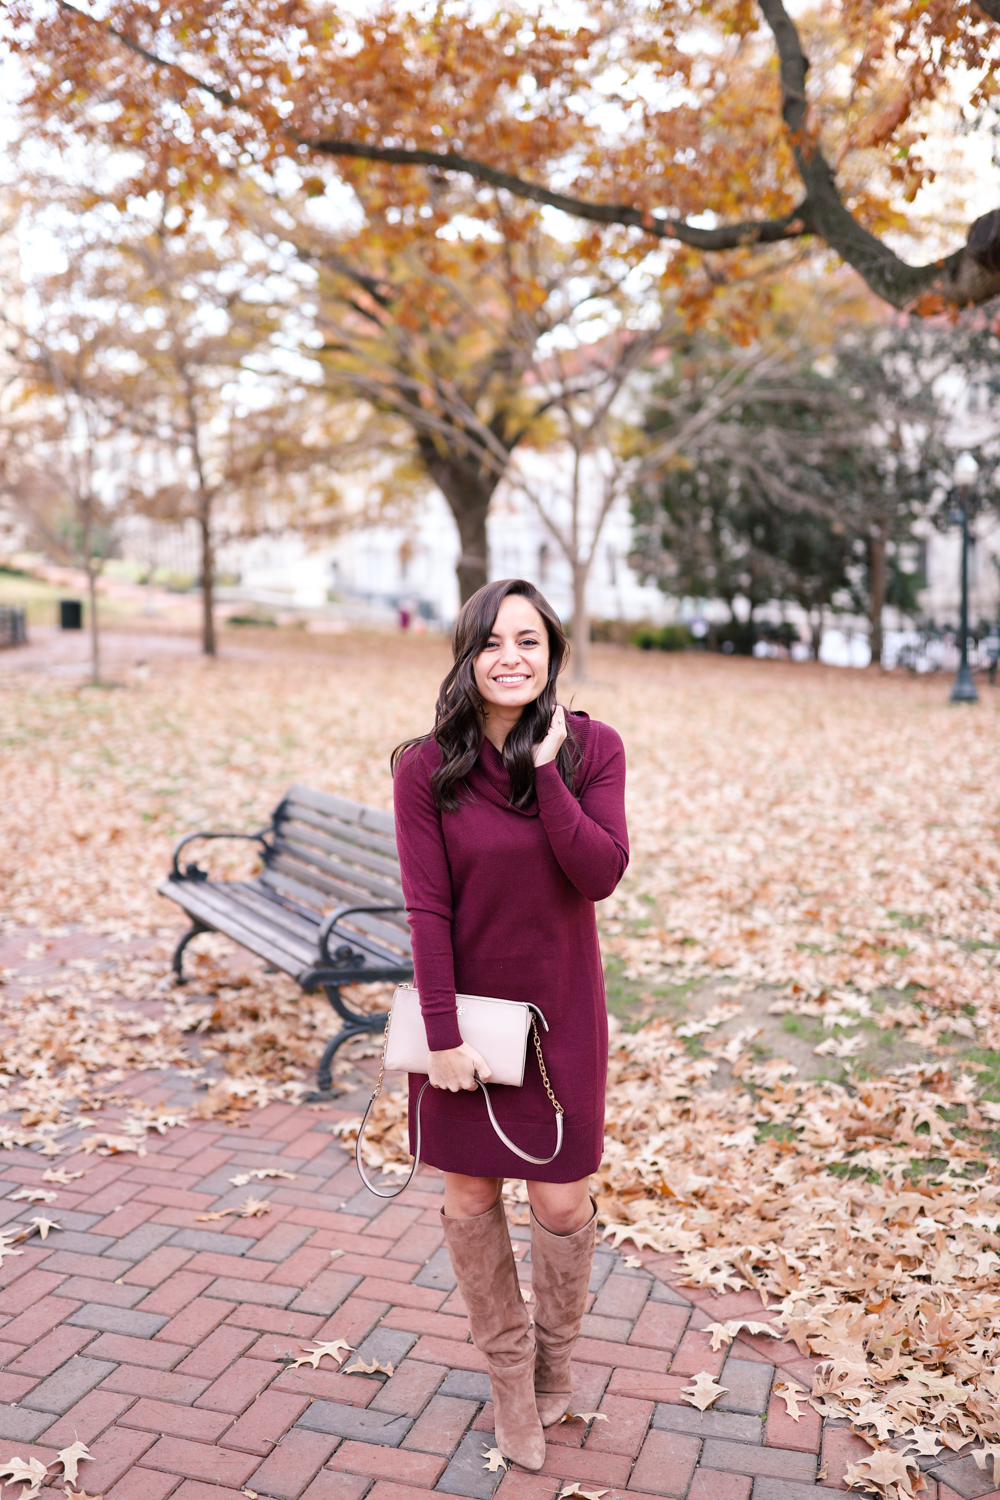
[441,1203,546,1470]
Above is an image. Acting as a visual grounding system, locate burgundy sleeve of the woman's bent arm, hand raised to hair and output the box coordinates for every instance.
[535,725,628,902]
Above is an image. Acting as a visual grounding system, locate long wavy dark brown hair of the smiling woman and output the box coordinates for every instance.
[390,578,579,812]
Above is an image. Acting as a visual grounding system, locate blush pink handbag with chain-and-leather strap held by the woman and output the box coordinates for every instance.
[354,984,564,1199]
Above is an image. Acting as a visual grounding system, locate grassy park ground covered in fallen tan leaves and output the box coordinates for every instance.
[0,635,1000,1496]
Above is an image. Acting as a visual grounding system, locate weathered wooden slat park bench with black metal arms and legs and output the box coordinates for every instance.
[159,786,414,1094]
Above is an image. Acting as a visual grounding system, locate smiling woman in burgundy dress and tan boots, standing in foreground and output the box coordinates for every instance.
[393,579,628,1470]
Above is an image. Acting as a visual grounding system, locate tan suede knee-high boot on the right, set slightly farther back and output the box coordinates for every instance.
[531,1208,597,1427]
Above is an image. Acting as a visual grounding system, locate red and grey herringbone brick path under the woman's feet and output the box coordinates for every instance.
[0,930,1000,1500]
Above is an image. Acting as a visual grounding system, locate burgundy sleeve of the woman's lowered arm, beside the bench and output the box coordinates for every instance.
[393,747,462,1052]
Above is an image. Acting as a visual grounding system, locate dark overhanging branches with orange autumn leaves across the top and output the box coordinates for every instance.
[7,0,1000,312]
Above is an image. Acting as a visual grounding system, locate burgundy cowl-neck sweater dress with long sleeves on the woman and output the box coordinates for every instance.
[394,714,628,1182]
